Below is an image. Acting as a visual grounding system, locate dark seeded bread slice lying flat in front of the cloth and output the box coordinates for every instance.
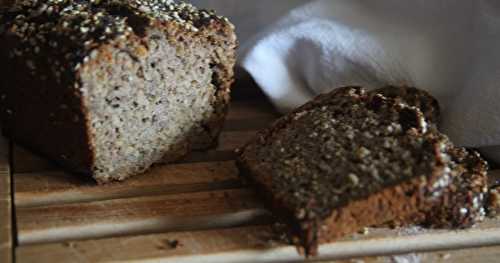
[237,87,488,255]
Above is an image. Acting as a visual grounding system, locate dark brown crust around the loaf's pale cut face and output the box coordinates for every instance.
[0,1,237,182]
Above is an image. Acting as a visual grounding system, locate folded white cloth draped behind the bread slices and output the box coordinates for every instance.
[241,0,500,161]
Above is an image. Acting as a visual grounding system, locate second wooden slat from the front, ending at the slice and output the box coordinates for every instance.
[16,190,268,244]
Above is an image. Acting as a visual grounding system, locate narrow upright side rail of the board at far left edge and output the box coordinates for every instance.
[0,136,13,262]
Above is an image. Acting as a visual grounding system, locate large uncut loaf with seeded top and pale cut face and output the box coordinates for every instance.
[0,0,237,182]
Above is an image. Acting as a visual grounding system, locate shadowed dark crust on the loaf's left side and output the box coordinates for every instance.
[0,29,93,174]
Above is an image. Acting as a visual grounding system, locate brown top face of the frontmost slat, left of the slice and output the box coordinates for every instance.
[16,226,276,263]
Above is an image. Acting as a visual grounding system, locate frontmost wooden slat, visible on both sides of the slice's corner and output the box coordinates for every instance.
[16,219,500,263]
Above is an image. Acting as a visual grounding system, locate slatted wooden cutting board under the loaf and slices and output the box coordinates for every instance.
[0,79,500,262]
